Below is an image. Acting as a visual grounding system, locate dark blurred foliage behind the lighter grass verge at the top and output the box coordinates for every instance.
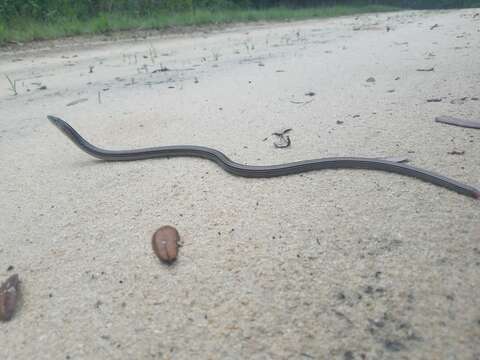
[0,0,480,21]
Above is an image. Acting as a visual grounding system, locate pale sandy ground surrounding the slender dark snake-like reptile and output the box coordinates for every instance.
[0,9,480,359]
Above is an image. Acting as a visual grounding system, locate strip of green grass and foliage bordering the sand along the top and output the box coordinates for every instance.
[0,0,480,44]
